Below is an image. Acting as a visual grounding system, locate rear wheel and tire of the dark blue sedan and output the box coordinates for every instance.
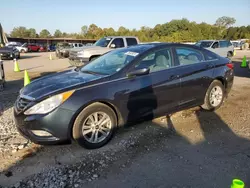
[201,80,225,111]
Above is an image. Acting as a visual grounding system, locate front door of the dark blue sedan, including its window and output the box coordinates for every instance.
[114,49,181,121]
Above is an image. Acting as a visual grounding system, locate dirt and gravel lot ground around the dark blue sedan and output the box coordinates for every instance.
[0,51,250,188]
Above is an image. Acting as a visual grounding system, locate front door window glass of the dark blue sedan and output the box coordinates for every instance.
[135,49,172,72]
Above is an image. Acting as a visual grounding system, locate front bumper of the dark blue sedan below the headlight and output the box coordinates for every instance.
[14,105,74,145]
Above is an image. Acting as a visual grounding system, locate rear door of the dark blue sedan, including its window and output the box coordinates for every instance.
[175,47,214,107]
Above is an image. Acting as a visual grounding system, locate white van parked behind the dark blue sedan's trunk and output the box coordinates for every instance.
[195,40,234,58]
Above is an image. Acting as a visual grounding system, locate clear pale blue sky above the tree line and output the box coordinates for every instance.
[0,0,250,34]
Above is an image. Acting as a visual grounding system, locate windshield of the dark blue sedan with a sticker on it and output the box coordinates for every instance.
[81,48,147,75]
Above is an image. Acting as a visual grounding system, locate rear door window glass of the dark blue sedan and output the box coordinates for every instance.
[176,48,203,65]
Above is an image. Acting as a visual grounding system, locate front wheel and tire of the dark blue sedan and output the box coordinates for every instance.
[72,103,117,149]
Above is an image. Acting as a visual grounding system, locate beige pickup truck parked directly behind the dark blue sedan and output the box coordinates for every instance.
[69,36,139,66]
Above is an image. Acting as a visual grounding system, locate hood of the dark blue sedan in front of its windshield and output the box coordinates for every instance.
[20,70,104,100]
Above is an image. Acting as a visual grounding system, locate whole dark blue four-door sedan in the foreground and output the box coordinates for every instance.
[14,43,234,148]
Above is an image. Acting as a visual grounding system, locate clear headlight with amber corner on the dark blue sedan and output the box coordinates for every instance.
[24,90,75,115]
